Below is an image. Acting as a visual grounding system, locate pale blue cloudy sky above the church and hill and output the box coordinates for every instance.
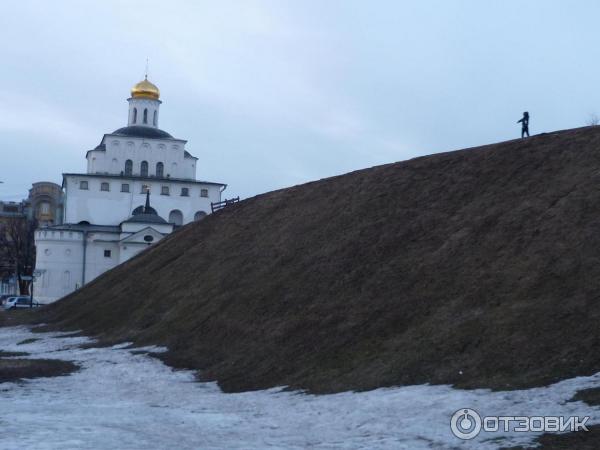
[0,0,600,200]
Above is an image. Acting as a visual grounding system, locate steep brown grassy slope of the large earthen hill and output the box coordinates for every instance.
[38,127,600,392]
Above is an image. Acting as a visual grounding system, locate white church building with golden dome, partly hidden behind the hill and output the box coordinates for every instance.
[34,77,226,303]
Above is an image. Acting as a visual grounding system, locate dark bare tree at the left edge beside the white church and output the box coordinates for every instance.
[0,217,37,295]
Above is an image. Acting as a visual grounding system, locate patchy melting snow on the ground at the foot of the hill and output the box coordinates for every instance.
[0,327,600,450]
